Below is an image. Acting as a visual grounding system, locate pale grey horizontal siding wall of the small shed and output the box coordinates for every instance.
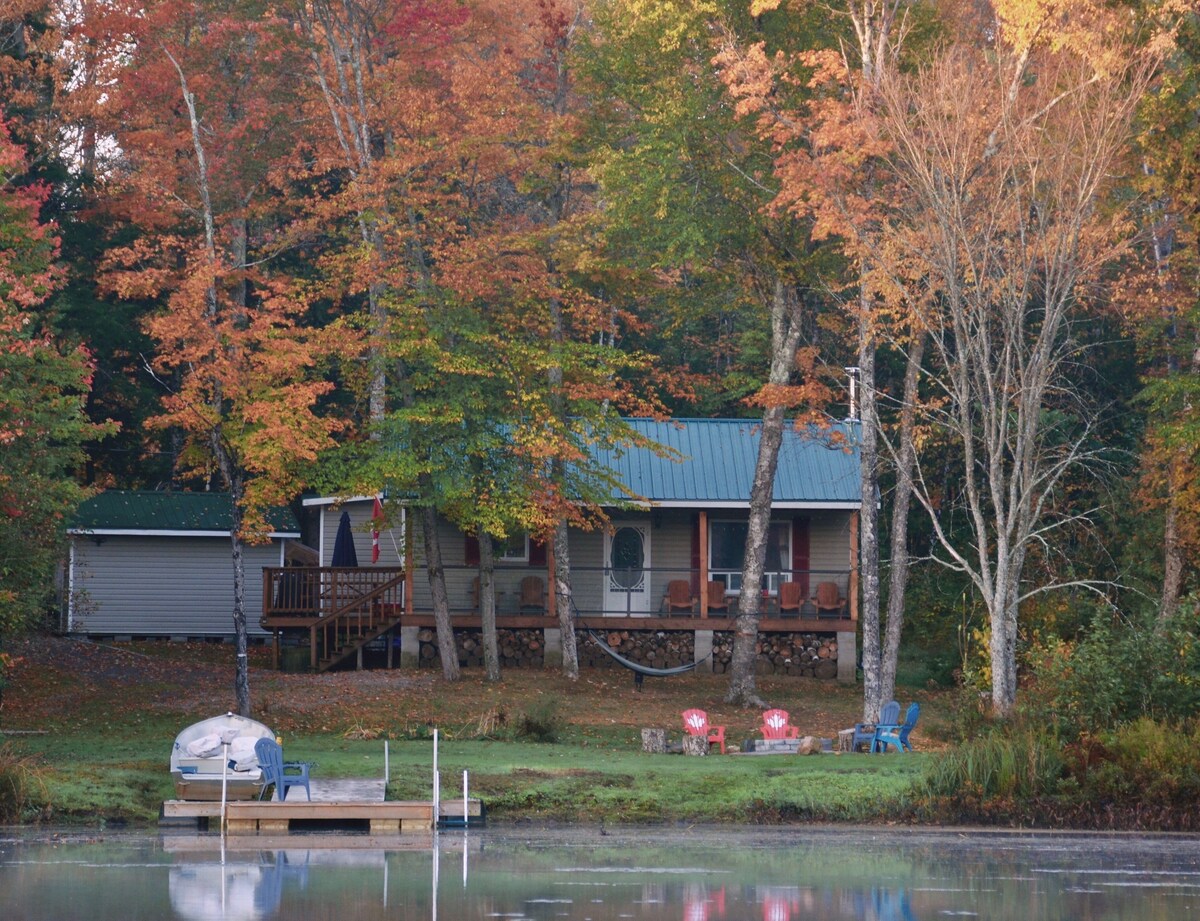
[67,535,281,637]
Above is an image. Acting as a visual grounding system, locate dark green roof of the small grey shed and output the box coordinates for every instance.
[71,489,300,537]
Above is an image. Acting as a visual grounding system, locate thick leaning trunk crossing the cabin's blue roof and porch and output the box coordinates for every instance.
[725,278,800,708]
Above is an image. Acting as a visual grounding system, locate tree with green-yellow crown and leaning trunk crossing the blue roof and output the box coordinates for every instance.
[593,0,829,706]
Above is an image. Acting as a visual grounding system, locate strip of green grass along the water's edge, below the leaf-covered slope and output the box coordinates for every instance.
[0,732,926,825]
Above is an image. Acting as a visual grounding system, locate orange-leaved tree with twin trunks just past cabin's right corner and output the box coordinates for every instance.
[725,0,922,721]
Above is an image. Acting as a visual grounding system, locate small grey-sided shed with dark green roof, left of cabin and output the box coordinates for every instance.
[60,489,304,639]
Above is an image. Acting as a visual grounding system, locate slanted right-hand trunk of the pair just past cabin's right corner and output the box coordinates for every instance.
[878,332,925,706]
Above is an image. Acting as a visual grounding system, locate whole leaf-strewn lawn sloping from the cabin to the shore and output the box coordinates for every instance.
[0,637,947,825]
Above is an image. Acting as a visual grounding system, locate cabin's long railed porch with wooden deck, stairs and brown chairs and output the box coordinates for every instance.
[260,555,857,670]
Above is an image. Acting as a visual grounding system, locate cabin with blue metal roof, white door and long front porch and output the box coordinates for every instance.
[263,419,860,681]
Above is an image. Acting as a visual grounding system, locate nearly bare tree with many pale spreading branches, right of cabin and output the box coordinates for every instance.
[878,32,1148,714]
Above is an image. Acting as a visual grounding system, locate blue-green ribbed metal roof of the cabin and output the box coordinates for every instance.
[595,419,862,508]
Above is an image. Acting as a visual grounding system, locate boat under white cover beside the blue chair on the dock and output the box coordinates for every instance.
[170,714,275,800]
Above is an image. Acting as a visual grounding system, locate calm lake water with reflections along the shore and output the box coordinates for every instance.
[0,827,1200,921]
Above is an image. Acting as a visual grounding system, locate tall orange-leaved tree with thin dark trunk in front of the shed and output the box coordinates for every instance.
[95,2,336,715]
